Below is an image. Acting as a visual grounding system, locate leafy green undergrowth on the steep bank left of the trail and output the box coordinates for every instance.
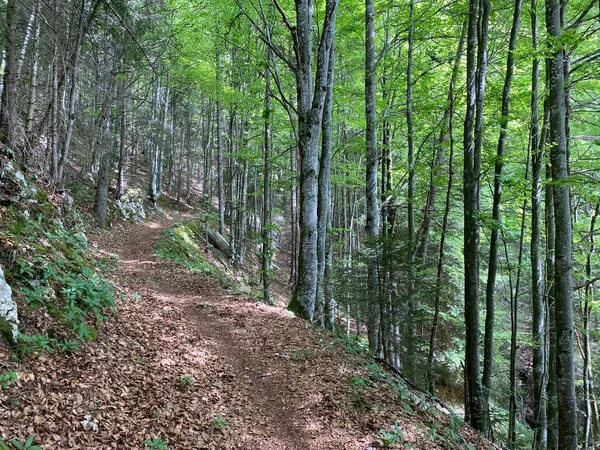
[0,197,116,356]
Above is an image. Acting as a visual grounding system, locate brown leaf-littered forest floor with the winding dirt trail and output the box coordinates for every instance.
[0,216,491,450]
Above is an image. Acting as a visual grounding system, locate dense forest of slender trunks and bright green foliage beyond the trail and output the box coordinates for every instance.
[0,0,600,450]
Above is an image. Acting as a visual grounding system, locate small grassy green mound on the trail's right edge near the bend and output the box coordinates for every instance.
[155,220,248,294]
